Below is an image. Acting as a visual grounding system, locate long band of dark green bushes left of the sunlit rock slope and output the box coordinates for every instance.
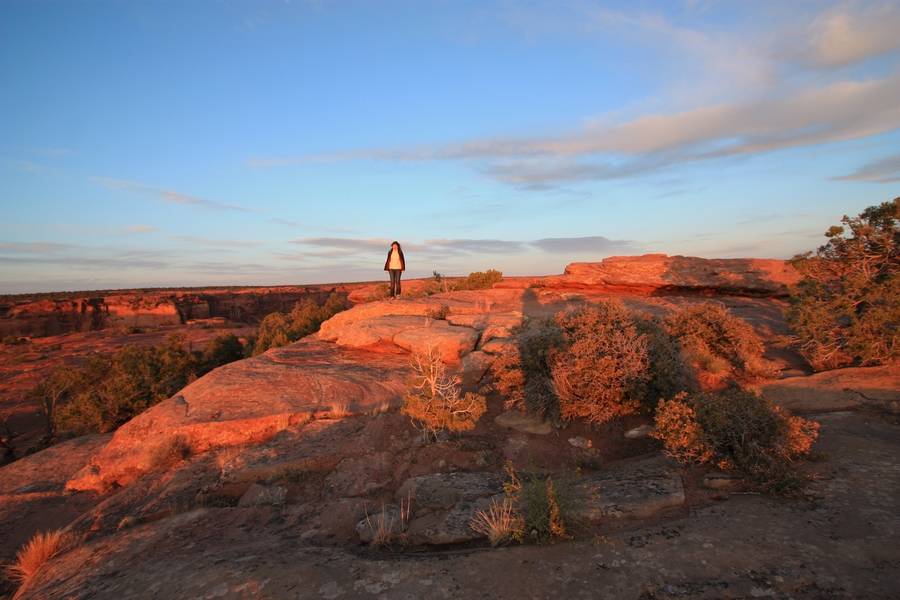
[30,334,244,442]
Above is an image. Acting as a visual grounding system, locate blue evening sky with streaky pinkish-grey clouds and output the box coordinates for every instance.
[0,0,900,293]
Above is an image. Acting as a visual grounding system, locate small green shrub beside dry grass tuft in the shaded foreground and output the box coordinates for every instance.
[503,463,572,543]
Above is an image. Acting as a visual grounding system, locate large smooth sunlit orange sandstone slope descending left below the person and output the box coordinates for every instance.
[66,340,409,491]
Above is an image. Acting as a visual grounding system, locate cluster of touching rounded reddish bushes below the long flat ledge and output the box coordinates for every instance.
[492,300,770,424]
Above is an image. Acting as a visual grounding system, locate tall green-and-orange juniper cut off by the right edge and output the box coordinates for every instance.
[788,198,900,370]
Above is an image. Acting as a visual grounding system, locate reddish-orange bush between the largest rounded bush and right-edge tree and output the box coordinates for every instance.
[665,303,772,379]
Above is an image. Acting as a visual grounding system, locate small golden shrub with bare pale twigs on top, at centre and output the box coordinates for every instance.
[402,348,487,439]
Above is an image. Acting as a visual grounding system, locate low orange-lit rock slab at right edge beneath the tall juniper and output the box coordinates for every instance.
[761,366,900,413]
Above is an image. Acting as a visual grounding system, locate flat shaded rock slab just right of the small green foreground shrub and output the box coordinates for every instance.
[575,458,684,523]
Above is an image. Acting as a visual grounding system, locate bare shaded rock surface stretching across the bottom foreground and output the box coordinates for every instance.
[22,413,900,600]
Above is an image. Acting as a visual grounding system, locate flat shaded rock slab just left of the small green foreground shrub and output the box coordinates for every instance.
[397,472,503,512]
